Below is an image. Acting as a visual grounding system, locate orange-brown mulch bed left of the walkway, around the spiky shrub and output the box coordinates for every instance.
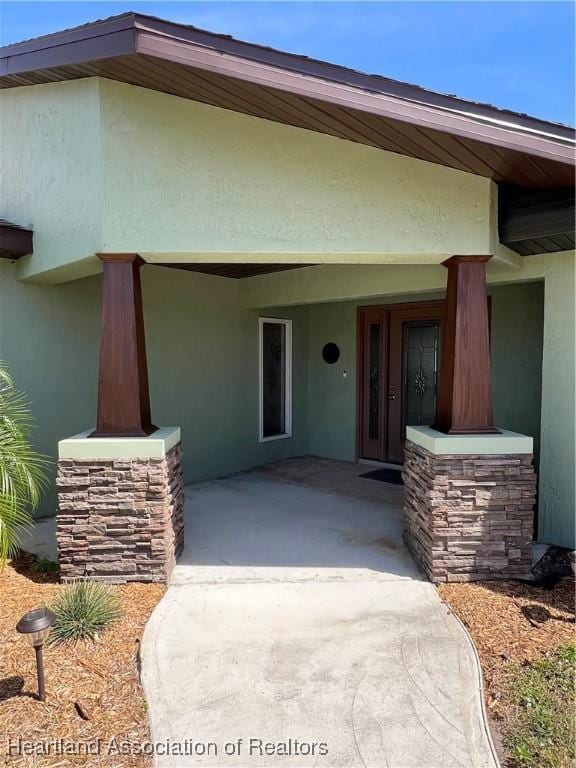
[0,555,165,768]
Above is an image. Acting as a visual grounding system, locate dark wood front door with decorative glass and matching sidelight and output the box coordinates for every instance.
[358,301,445,463]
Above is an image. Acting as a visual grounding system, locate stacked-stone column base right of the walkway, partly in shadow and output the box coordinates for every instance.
[403,427,536,582]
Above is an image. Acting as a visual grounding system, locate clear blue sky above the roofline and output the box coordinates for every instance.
[0,0,575,124]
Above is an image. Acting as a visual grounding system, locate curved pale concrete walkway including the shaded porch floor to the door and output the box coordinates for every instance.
[142,459,497,768]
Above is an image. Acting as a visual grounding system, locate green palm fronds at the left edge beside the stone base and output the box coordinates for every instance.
[0,363,48,570]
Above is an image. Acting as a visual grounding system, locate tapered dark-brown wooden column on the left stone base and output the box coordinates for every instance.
[91,253,157,437]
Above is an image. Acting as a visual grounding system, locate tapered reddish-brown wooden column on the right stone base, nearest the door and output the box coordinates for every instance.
[434,256,499,435]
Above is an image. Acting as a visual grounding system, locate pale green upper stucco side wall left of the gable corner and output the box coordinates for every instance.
[0,79,101,277]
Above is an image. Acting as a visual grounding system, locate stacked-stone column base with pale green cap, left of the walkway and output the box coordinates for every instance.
[56,428,184,583]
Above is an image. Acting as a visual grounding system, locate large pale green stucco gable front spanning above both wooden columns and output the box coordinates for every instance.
[100,80,490,254]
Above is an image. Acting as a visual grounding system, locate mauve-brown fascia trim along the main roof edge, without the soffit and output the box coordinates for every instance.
[0,13,575,166]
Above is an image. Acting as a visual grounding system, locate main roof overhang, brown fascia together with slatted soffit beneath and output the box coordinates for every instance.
[0,13,574,194]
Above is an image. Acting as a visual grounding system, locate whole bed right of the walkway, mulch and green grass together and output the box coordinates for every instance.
[438,577,576,768]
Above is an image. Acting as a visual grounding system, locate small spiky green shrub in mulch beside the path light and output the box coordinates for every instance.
[50,581,122,643]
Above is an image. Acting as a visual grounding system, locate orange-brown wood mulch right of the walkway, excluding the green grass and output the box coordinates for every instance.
[438,577,576,765]
